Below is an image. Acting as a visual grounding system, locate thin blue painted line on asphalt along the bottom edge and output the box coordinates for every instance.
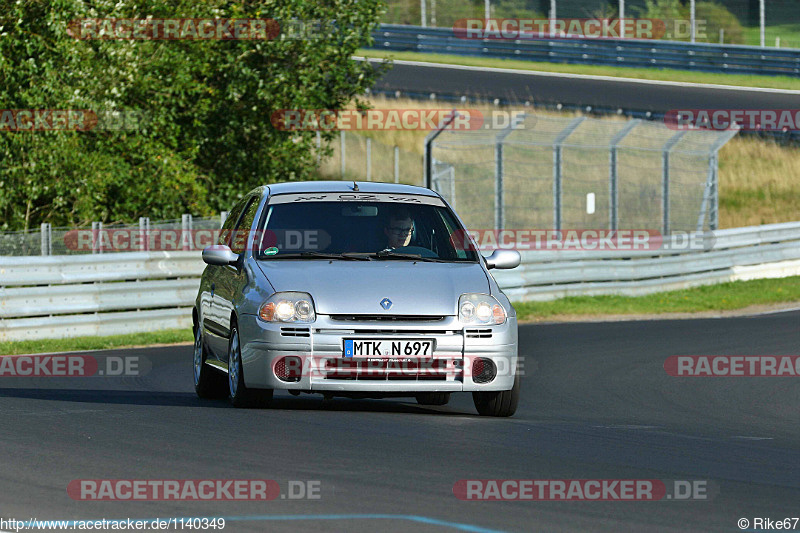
[32,514,505,533]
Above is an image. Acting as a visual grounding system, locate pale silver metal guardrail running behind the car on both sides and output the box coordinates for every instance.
[0,222,800,341]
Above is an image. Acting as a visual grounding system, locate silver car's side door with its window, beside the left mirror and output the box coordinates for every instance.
[214,195,259,362]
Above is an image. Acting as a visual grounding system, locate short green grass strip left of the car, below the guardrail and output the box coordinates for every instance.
[0,329,193,355]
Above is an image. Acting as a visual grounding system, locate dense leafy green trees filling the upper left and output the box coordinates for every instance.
[0,0,380,229]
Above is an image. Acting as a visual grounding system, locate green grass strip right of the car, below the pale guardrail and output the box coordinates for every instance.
[514,276,800,320]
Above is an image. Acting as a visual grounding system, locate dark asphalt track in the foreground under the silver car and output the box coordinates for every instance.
[0,312,800,532]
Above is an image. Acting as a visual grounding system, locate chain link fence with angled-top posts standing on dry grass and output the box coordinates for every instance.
[426,114,737,235]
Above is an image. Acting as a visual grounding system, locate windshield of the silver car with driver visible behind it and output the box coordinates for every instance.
[258,195,479,262]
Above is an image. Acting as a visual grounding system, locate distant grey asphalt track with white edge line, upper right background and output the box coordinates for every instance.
[375,61,800,114]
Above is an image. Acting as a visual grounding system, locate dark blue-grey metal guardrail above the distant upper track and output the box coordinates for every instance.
[372,24,800,77]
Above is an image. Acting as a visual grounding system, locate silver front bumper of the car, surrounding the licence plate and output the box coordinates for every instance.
[238,315,517,393]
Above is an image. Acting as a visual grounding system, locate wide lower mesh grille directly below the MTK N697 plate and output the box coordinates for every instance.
[323,359,456,381]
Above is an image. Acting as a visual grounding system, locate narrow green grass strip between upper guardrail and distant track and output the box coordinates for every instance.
[359,50,800,90]
